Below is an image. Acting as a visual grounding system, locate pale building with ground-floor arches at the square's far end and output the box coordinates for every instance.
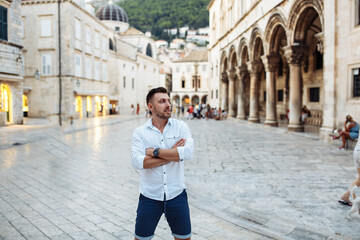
[170,50,209,107]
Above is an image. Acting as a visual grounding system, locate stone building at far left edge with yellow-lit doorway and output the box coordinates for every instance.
[0,0,24,126]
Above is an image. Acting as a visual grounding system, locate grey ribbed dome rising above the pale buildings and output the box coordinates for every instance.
[95,0,129,23]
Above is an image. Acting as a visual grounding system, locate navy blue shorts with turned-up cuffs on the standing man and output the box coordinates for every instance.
[135,190,191,240]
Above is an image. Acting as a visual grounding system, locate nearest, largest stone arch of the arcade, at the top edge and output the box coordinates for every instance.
[287,0,324,44]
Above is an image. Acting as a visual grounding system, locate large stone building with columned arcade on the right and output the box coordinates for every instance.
[208,0,360,139]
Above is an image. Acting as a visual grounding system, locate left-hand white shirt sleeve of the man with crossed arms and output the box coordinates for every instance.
[131,128,145,170]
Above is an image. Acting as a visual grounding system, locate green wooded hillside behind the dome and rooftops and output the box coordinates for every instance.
[117,0,209,40]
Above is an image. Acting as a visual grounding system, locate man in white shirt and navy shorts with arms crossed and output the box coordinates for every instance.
[131,87,194,240]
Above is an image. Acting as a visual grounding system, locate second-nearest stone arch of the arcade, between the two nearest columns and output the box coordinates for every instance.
[264,10,289,54]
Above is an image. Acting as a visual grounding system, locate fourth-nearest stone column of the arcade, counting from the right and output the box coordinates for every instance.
[236,65,248,120]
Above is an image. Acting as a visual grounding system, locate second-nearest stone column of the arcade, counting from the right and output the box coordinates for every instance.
[262,54,280,127]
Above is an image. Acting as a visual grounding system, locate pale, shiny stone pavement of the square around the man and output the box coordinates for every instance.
[0,116,360,240]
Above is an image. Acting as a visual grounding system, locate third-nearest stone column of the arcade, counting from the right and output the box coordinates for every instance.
[247,61,262,123]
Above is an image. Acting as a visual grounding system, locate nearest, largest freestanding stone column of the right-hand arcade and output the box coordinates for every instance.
[284,45,306,132]
